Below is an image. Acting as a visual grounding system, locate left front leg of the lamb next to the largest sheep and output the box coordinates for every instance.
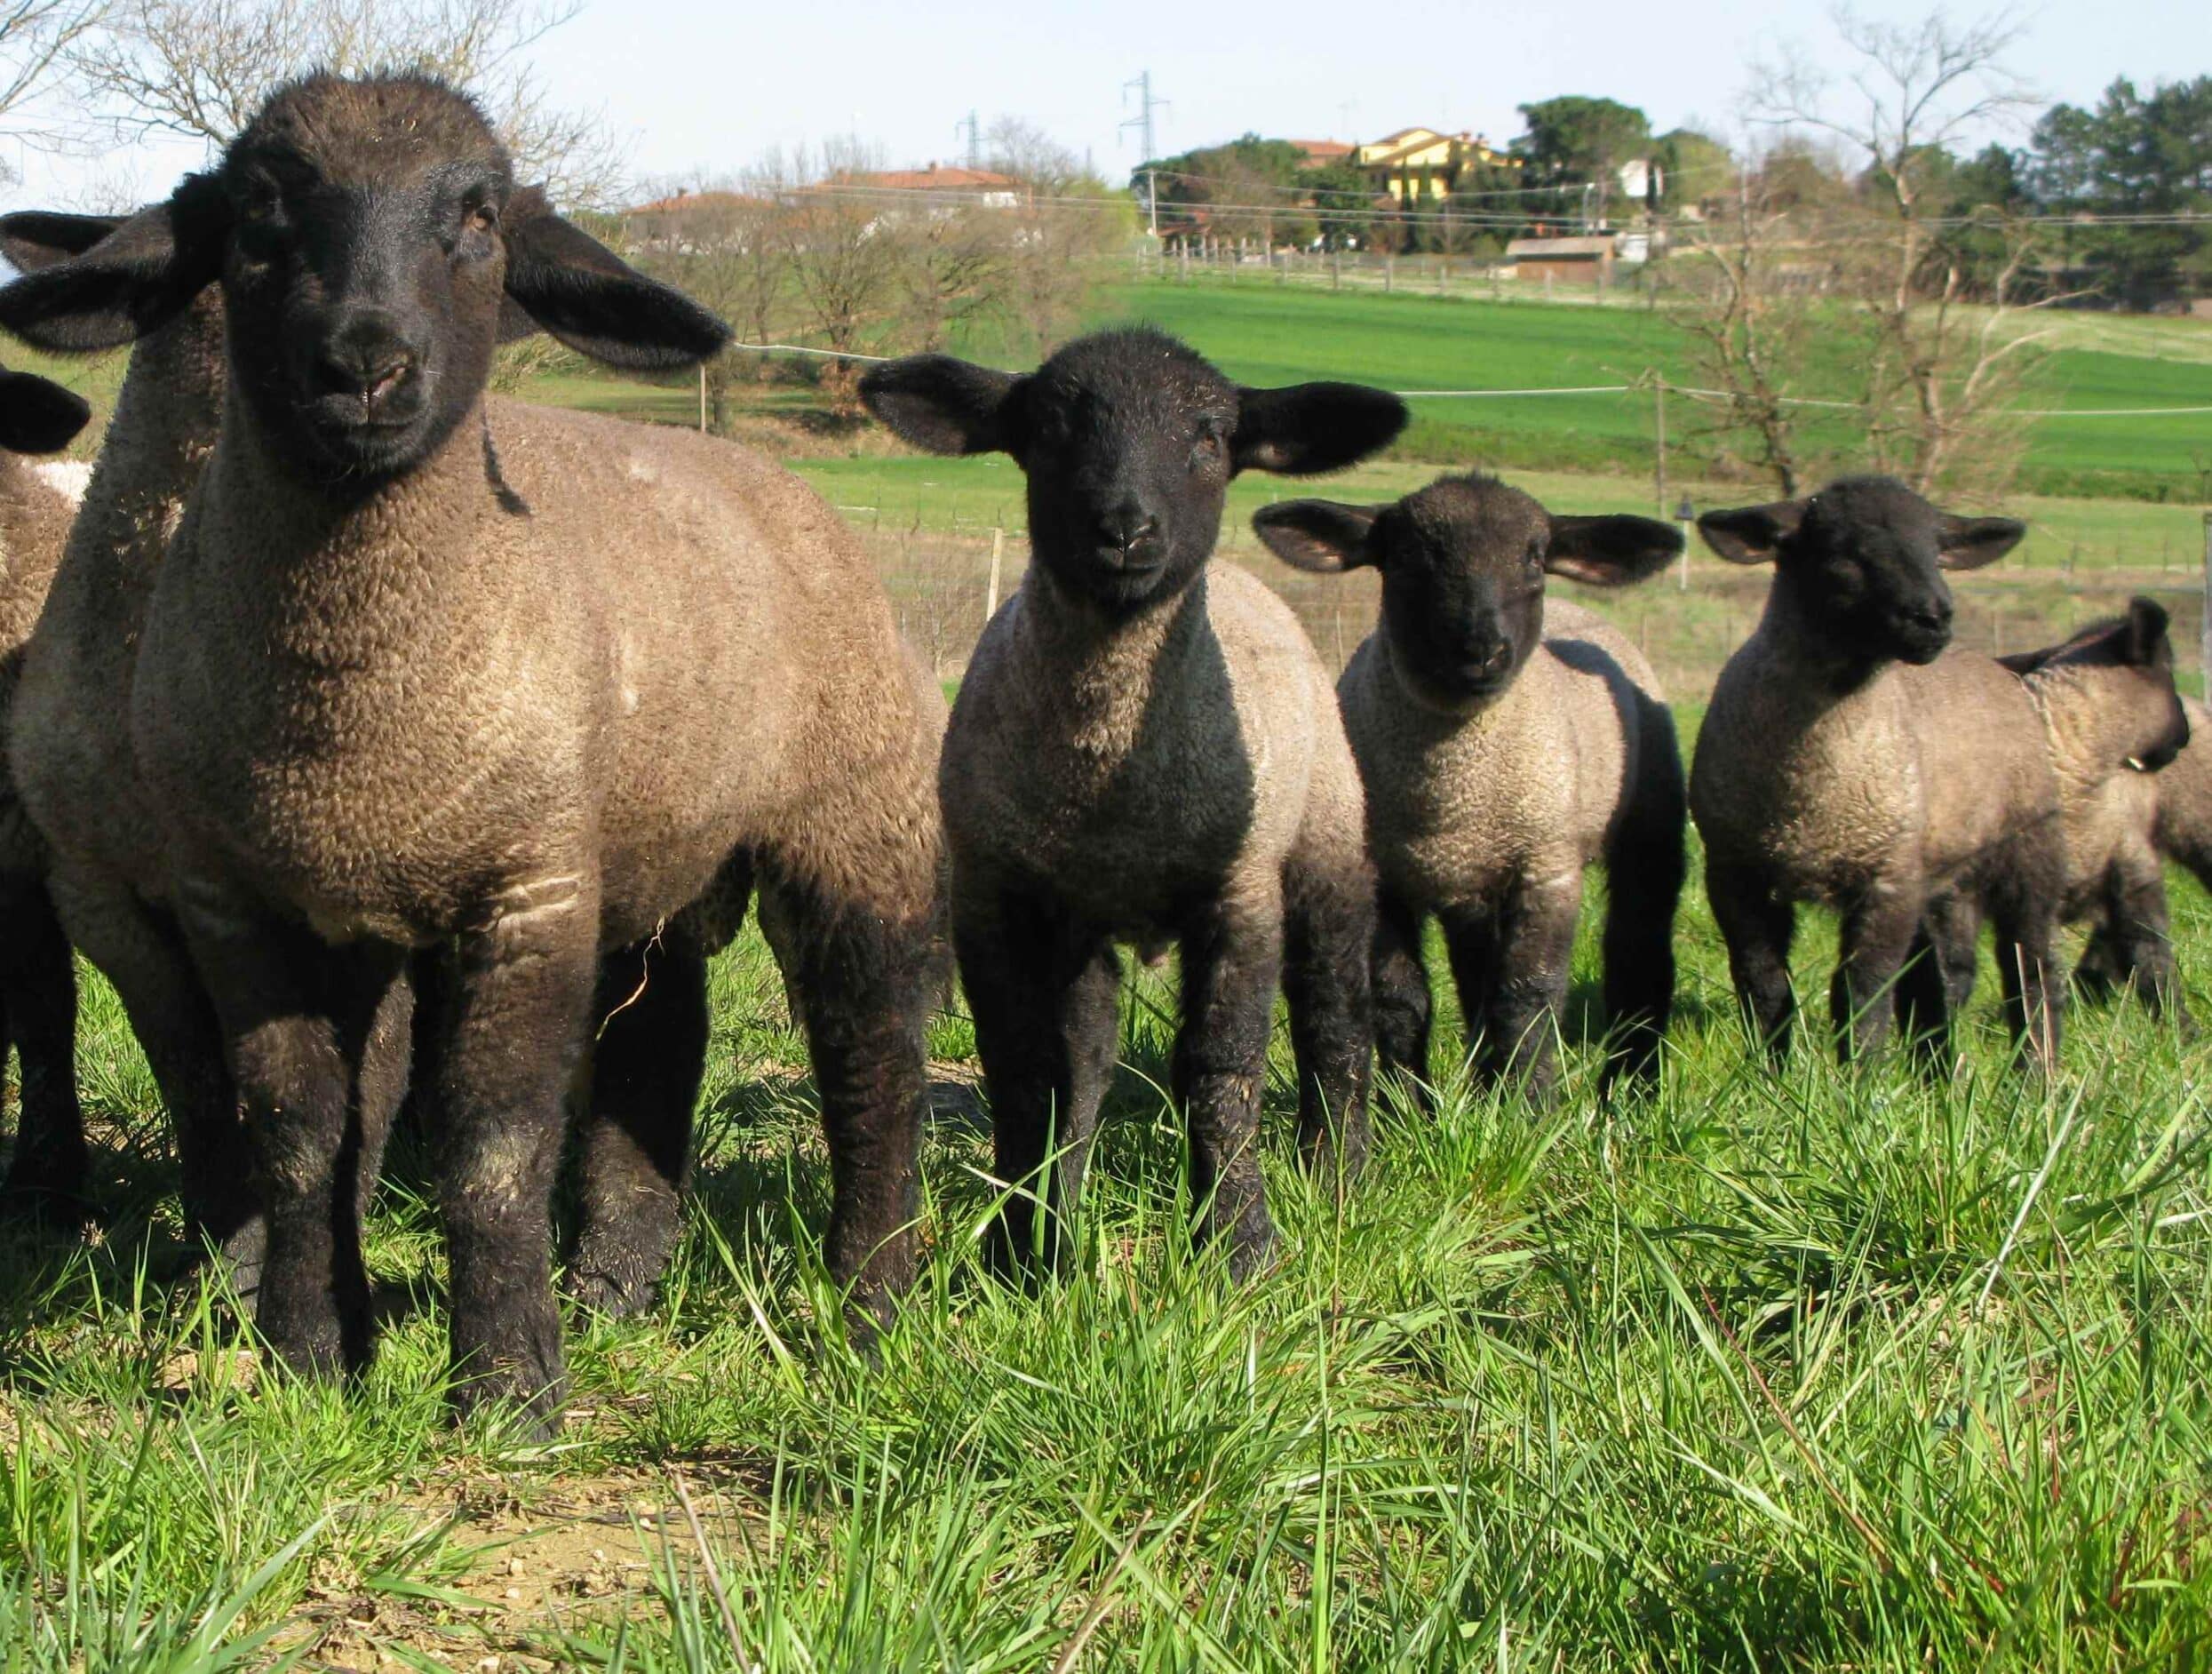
[953,891,1121,1274]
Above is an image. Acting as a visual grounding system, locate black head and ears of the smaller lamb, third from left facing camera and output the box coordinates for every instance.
[1252,475,1681,714]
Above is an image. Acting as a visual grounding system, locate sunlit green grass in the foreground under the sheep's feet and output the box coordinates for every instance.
[0,778,2212,1674]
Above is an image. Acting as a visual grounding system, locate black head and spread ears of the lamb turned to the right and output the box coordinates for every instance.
[1699,478,2024,668]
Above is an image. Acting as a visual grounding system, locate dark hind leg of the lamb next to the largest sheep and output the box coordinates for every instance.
[1283,856,1376,1179]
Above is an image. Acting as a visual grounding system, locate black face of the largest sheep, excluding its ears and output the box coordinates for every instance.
[219,80,511,480]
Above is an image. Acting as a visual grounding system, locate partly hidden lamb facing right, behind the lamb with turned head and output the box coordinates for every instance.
[2008,597,2201,1024]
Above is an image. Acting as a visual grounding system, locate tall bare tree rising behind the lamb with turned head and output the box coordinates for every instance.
[1750,9,2059,491]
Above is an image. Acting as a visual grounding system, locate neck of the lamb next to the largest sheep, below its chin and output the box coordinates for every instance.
[1015,564,1213,738]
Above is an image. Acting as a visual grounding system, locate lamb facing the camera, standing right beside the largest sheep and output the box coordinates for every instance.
[861,330,1404,1279]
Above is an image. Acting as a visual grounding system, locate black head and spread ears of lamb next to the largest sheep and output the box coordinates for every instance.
[861,327,1407,617]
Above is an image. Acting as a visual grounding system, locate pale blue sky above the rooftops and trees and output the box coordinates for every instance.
[20,0,2212,201]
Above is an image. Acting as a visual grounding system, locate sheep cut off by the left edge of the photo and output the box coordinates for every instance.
[0,358,91,1212]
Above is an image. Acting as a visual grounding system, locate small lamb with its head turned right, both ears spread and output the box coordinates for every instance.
[1690,478,2066,1068]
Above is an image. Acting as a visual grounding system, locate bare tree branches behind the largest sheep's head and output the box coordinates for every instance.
[62,0,624,208]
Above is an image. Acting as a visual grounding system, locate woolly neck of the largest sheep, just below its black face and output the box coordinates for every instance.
[193,394,496,666]
